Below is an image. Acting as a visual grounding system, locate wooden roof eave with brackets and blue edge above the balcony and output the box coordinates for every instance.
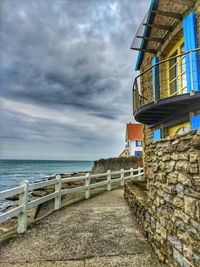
[131,0,195,70]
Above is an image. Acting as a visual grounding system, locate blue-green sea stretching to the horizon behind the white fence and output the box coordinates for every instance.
[0,160,93,211]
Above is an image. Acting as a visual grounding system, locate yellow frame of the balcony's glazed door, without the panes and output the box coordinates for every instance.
[167,37,186,97]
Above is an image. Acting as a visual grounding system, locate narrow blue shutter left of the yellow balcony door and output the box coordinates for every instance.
[152,56,160,100]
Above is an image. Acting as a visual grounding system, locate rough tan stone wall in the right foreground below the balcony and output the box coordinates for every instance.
[125,131,200,267]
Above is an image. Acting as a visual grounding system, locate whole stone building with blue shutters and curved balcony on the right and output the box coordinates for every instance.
[125,0,200,267]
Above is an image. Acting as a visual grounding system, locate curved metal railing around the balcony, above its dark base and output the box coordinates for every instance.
[133,48,200,113]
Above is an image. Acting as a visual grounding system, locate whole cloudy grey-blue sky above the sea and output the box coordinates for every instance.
[0,0,150,160]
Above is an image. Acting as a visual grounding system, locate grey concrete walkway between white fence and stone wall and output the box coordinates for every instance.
[0,189,160,267]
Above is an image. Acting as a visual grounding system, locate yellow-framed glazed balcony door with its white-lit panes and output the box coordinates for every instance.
[167,38,187,96]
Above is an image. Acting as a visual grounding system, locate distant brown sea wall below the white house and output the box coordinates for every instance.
[92,157,143,173]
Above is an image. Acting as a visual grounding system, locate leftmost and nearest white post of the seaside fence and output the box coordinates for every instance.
[17,180,29,234]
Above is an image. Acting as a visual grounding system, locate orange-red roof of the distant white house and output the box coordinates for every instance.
[126,123,143,140]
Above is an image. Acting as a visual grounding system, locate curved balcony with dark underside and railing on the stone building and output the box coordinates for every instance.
[133,48,200,127]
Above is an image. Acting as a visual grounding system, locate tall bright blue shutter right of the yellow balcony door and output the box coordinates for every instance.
[183,12,200,93]
